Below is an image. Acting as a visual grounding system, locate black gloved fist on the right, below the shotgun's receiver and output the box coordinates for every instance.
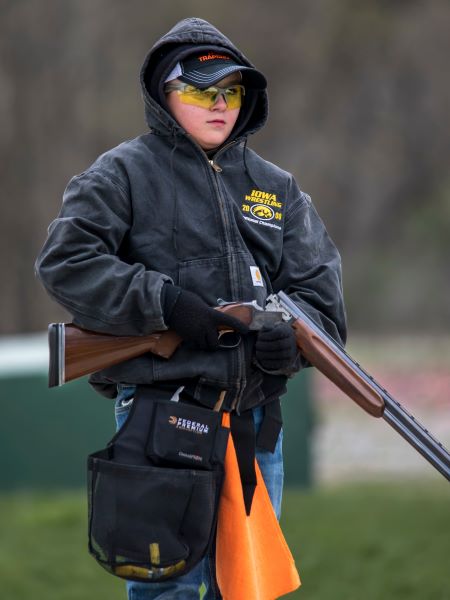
[255,323,297,371]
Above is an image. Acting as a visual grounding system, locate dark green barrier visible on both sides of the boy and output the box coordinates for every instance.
[0,371,312,491]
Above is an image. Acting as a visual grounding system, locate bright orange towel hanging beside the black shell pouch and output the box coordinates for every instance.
[216,413,300,600]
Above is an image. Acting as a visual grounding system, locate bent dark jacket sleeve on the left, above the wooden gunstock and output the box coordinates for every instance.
[36,170,172,335]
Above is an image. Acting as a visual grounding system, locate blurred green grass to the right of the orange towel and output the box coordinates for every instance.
[282,480,450,600]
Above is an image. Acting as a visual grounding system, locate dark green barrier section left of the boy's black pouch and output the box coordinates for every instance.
[0,374,115,490]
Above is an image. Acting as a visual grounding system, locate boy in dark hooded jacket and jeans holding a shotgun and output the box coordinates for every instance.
[37,18,345,600]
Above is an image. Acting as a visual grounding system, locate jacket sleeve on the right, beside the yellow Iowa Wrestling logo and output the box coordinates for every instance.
[272,185,347,345]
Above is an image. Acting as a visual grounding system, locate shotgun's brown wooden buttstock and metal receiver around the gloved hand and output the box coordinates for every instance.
[48,302,274,387]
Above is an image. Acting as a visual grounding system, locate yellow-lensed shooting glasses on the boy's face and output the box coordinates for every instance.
[164,81,245,110]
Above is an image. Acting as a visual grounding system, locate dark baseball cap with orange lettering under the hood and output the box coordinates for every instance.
[165,50,267,90]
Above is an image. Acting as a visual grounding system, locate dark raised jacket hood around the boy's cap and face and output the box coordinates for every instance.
[140,17,268,139]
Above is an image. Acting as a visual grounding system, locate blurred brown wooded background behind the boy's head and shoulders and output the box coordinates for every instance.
[0,0,450,333]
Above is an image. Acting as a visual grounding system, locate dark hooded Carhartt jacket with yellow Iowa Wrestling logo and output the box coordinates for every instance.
[36,18,345,407]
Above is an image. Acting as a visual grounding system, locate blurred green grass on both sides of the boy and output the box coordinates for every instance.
[0,480,450,600]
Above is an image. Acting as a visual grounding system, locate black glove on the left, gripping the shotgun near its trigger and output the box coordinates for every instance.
[162,284,248,350]
